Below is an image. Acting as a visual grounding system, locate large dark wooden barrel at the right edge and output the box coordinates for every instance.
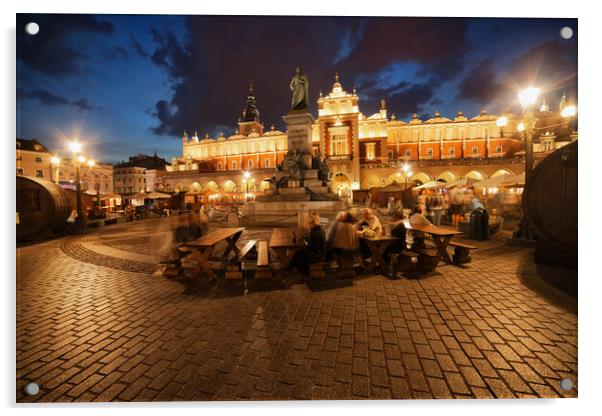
[522,141,578,266]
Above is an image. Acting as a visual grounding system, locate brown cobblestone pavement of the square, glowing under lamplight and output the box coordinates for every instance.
[16,219,577,402]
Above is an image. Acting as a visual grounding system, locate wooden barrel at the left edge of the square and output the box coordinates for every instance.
[17,176,72,241]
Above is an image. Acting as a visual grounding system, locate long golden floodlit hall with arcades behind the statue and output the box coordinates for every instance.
[163,74,577,191]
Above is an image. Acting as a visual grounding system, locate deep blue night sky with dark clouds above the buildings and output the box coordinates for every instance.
[17,15,577,162]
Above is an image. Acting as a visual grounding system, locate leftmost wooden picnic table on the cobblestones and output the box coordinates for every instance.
[183,227,245,279]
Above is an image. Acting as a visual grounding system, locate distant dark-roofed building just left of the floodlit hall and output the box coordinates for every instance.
[113,152,167,195]
